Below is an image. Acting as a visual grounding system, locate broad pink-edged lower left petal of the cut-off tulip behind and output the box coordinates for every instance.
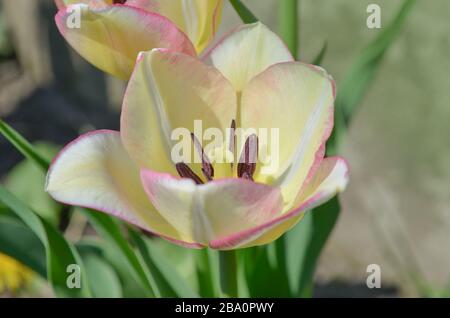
[55,4,196,80]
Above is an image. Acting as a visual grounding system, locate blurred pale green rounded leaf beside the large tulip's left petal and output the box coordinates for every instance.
[5,143,62,226]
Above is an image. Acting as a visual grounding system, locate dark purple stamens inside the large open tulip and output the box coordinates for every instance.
[175,119,258,184]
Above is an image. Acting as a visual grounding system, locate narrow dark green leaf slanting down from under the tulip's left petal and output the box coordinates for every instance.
[80,209,159,296]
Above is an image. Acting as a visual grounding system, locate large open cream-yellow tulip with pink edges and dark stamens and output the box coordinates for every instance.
[46,23,348,250]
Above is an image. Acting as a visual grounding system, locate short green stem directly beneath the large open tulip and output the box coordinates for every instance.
[219,250,238,298]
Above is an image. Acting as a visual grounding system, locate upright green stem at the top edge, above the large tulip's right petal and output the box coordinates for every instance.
[278,0,298,59]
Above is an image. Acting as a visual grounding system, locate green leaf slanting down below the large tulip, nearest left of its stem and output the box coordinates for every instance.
[129,229,199,298]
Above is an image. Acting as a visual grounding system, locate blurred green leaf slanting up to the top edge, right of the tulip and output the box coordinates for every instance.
[336,0,416,125]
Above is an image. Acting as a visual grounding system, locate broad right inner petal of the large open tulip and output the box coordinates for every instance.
[241,62,334,205]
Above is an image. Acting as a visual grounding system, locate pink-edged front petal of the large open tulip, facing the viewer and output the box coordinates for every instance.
[141,170,282,245]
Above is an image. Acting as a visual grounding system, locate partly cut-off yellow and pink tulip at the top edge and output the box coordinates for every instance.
[55,0,222,80]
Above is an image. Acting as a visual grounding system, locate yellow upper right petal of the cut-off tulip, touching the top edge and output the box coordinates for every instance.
[126,0,223,52]
